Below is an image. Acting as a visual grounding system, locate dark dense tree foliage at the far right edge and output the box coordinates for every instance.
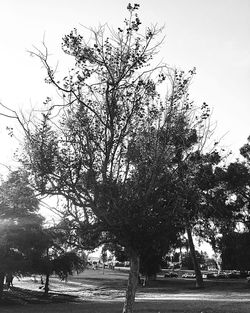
[198,135,250,270]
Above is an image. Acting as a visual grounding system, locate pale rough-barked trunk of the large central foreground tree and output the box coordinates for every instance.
[122,254,139,313]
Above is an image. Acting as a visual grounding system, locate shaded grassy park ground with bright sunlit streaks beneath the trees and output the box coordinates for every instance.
[0,270,250,313]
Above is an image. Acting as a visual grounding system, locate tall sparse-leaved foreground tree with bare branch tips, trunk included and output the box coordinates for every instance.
[0,4,216,313]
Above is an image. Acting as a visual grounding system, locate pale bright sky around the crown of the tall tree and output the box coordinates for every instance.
[0,0,250,172]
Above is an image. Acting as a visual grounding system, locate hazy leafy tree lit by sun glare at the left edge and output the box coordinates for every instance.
[0,170,43,297]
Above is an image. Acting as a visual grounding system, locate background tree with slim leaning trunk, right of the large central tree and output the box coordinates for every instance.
[160,126,220,287]
